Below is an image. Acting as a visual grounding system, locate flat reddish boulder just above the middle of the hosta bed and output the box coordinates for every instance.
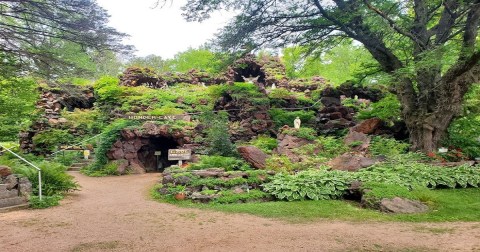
[329,153,378,172]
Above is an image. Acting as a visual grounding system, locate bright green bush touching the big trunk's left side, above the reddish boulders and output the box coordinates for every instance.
[357,94,401,122]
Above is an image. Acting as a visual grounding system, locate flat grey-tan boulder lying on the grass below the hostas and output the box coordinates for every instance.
[380,197,428,214]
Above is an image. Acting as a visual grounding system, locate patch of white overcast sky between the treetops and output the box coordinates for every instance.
[97,0,232,59]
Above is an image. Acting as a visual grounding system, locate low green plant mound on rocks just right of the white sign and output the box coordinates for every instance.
[189,156,251,171]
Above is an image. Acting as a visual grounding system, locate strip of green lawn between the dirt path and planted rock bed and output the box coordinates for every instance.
[152,188,480,223]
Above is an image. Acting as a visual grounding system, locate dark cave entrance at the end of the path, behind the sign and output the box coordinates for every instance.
[137,136,178,172]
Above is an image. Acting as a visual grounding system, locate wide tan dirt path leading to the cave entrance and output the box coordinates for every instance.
[0,173,480,252]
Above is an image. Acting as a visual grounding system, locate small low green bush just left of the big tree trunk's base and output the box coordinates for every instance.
[369,136,410,157]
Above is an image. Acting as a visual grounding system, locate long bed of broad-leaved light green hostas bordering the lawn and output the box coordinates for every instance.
[263,157,480,201]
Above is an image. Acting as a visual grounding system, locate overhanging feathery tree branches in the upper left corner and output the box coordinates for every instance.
[0,0,130,76]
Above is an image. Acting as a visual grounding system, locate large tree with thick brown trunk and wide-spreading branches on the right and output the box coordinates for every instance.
[178,0,480,152]
